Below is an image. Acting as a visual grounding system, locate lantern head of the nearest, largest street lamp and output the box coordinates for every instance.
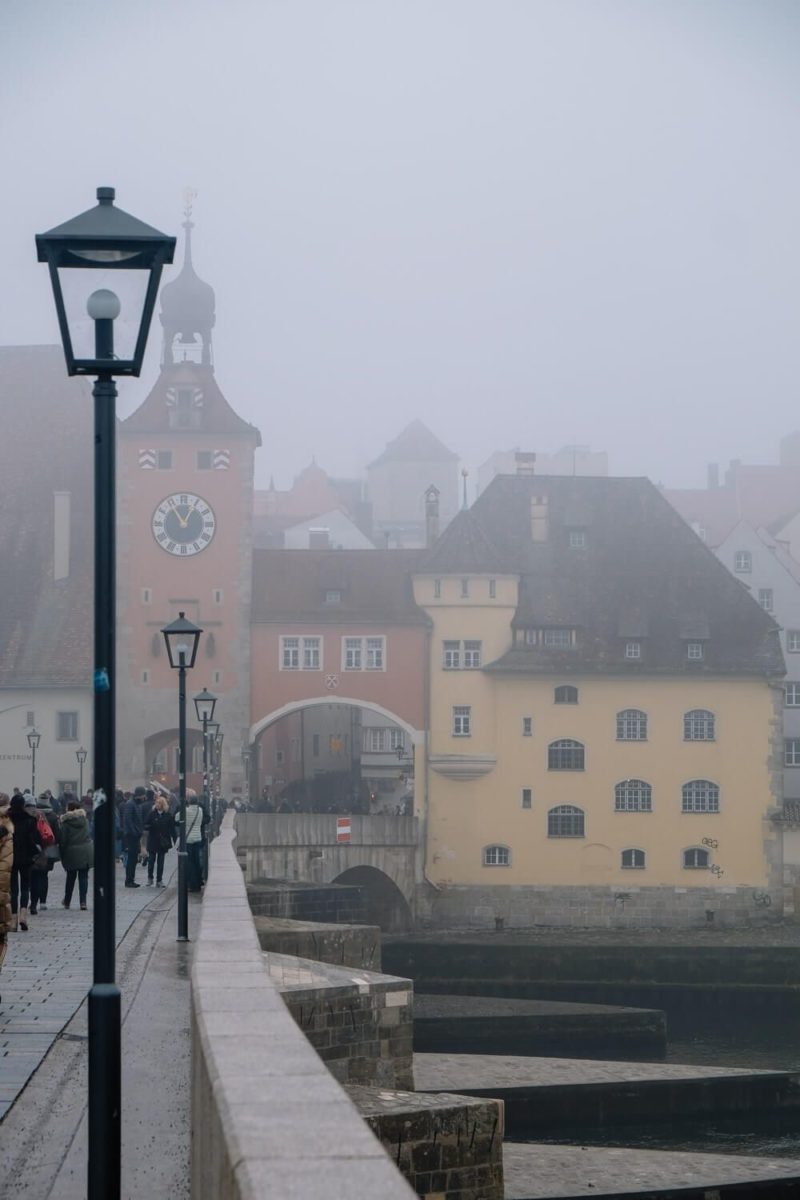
[36,187,175,376]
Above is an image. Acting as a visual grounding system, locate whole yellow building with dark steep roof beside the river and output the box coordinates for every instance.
[414,474,783,926]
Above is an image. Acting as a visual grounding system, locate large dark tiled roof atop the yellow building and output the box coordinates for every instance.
[443,475,783,674]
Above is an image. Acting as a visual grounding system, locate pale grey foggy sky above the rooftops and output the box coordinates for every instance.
[0,0,800,486]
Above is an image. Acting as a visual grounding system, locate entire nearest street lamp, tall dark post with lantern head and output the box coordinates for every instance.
[36,187,175,1200]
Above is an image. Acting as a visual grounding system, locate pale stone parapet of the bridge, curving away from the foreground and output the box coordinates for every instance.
[192,816,414,1200]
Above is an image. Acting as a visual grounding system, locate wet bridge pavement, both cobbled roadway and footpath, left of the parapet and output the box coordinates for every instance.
[0,868,200,1200]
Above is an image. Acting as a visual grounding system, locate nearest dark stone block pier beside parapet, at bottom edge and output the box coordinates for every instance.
[348,1087,504,1200]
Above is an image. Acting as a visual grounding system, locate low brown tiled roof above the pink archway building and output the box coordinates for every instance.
[252,550,427,625]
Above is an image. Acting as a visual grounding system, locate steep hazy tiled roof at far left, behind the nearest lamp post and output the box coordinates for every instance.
[0,346,94,688]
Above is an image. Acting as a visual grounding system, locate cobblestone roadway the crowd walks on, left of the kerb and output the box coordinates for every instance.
[0,865,172,1121]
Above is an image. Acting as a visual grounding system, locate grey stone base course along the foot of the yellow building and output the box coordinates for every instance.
[416,884,782,930]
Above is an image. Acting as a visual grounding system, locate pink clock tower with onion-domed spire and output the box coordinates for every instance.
[118,206,261,794]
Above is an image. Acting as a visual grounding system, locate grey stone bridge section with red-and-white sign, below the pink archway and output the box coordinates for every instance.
[236,812,419,924]
